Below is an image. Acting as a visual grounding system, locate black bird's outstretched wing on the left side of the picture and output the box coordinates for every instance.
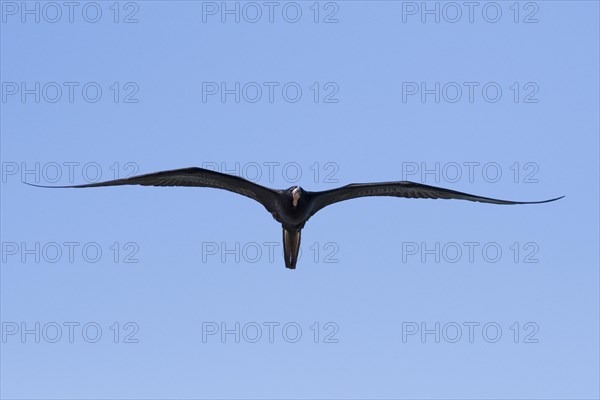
[28,168,278,212]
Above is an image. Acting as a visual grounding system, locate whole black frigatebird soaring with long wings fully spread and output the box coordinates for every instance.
[27,168,564,269]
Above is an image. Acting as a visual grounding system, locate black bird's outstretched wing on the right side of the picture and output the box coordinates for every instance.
[311,181,564,215]
